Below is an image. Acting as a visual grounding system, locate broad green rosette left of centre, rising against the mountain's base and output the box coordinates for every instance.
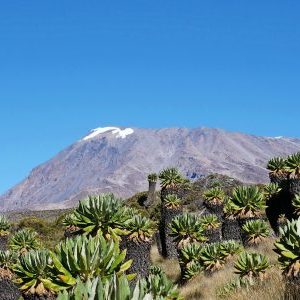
[74,194,130,239]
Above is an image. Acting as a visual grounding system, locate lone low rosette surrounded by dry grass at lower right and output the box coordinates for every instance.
[234,252,270,281]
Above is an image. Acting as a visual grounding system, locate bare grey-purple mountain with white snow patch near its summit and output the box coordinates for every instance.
[0,127,300,210]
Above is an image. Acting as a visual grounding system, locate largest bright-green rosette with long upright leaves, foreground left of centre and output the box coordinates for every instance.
[52,236,131,285]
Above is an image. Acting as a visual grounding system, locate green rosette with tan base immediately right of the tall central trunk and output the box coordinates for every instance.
[170,214,206,247]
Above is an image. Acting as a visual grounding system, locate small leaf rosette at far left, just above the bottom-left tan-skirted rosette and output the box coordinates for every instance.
[9,228,41,254]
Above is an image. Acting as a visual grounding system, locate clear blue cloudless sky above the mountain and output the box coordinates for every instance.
[0,0,300,193]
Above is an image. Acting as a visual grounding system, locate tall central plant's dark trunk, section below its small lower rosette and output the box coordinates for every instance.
[160,205,182,258]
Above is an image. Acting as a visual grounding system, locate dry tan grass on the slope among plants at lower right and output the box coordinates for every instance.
[151,238,288,300]
